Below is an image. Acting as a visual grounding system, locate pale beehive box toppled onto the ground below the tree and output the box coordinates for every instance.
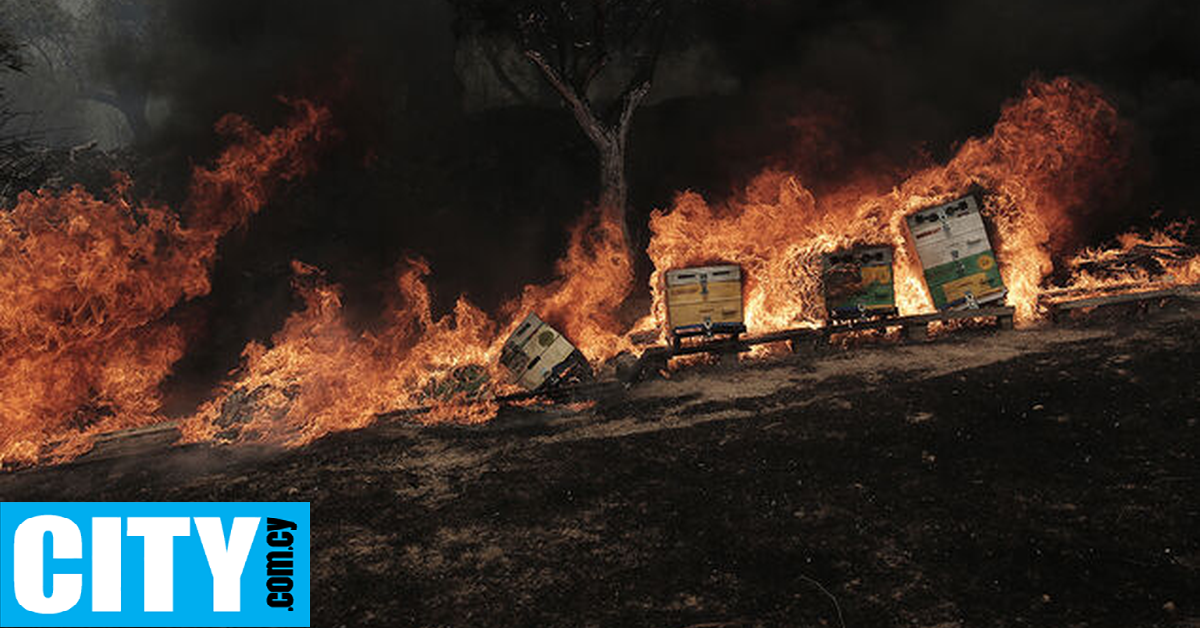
[500,313,592,390]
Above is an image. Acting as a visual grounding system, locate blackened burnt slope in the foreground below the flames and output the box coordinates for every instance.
[0,304,1200,628]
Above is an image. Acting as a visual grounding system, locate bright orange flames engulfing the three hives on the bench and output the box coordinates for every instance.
[640,78,1147,333]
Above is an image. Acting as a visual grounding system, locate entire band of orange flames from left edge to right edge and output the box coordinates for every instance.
[0,78,1200,466]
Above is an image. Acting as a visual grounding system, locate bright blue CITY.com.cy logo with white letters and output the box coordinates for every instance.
[0,502,311,627]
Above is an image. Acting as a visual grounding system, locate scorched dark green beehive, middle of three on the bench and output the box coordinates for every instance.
[821,246,896,321]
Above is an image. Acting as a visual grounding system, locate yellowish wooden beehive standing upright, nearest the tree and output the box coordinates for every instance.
[666,264,746,343]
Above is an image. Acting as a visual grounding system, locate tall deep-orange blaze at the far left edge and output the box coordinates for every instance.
[0,102,328,466]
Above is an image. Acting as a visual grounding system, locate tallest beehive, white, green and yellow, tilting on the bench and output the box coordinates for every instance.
[906,196,1008,310]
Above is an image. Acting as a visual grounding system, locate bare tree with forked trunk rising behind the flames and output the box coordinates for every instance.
[457,0,671,243]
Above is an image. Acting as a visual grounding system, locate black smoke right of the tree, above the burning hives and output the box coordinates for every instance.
[635,0,1200,225]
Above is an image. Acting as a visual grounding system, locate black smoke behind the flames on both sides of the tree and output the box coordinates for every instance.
[56,0,1200,408]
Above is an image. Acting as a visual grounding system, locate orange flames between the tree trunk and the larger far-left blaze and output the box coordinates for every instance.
[184,204,632,445]
